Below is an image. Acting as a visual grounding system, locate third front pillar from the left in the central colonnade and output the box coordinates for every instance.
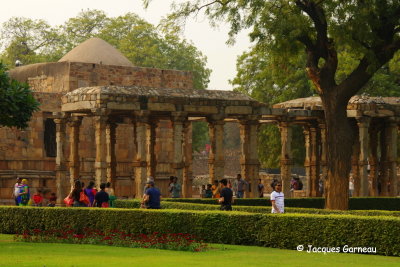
[94,115,108,188]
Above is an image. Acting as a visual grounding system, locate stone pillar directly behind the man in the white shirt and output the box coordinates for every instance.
[279,122,292,198]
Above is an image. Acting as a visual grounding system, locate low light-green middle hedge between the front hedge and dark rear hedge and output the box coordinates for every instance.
[115,199,400,217]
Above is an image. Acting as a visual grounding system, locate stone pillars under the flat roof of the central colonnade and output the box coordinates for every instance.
[55,110,259,201]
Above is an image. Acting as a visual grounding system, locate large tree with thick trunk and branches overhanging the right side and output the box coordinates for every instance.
[148,0,400,209]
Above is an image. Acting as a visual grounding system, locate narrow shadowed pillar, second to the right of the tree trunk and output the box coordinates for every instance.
[368,126,379,197]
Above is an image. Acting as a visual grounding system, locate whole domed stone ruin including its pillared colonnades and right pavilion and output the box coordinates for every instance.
[0,38,400,202]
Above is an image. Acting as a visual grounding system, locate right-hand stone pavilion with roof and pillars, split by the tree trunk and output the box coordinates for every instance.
[269,96,400,196]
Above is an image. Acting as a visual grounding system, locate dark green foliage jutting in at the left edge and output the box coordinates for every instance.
[0,62,39,128]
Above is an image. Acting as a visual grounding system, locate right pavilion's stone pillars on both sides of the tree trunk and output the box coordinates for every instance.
[279,117,398,197]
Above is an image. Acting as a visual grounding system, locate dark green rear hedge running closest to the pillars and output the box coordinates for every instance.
[161,197,400,211]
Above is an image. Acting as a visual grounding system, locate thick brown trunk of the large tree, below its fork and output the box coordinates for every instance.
[321,94,355,210]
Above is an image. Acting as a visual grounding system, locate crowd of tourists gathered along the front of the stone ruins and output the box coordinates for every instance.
[13,174,284,213]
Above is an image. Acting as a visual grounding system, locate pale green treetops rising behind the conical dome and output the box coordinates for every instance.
[0,10,211,89]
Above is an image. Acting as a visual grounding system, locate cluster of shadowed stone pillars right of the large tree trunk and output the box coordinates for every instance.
[352,117,399,196]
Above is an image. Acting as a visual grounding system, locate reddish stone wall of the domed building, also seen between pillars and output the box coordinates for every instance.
[0,62,193,199]
